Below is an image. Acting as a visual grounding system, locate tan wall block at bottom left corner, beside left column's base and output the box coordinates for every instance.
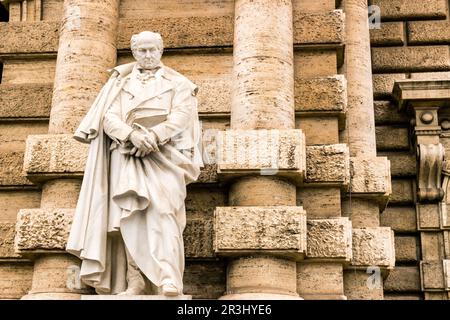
[0,262,33,299]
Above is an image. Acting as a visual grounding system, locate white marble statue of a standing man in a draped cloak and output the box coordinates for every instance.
[66,31,203,296]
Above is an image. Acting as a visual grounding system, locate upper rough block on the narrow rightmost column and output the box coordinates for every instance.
[350,157,392,198]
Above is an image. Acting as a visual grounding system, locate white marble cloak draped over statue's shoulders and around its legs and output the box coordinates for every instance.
[66,62,203,294]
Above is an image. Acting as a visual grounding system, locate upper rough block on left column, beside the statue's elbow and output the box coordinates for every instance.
[24,134,89,181]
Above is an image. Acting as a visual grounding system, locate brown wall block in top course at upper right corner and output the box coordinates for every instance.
[372,0,447,20]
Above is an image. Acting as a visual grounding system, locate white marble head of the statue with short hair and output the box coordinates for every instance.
[131,31,164,69]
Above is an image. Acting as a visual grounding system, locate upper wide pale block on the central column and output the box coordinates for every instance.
[217,129,306,184]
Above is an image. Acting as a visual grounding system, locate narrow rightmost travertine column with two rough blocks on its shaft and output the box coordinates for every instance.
[343,0,393,299]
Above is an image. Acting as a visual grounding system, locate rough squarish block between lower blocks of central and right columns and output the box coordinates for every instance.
[306,218,352,261]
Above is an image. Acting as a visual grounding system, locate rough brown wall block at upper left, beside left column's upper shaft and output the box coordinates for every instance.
[0,21,59,54]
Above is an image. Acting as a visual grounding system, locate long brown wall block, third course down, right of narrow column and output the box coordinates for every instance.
[372,46,450,73]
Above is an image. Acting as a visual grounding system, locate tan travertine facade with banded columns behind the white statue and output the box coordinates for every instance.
[0,0,450,300]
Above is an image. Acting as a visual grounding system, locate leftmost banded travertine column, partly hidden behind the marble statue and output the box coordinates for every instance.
[17,0,119,299]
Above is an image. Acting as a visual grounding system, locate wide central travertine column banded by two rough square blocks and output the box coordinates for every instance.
[215,0,304,299]
